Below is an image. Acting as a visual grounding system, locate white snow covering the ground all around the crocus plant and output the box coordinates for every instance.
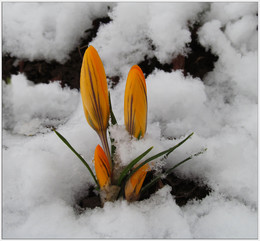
[2,3,258,238]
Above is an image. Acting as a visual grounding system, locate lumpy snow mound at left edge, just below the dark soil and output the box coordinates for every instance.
[3,75,79,135]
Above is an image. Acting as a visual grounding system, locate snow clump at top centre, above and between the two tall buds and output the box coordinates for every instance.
[92,3,207,76]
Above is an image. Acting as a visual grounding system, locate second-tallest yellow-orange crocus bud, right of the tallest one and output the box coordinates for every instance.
[124,65,147,138]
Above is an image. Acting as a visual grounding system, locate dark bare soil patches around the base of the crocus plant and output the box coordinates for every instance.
[75,172,211,214]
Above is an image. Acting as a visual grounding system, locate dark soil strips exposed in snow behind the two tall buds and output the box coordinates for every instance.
[2,17,218,89]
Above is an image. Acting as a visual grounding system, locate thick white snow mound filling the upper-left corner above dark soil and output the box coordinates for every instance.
[3,3,112,62]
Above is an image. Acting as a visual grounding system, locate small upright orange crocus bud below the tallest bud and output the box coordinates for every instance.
[94,145,111,189]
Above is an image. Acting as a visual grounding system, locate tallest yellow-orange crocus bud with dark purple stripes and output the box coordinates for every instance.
[80,46,109,132]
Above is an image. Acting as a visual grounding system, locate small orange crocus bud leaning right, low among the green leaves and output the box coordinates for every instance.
[125,163,150,201]
